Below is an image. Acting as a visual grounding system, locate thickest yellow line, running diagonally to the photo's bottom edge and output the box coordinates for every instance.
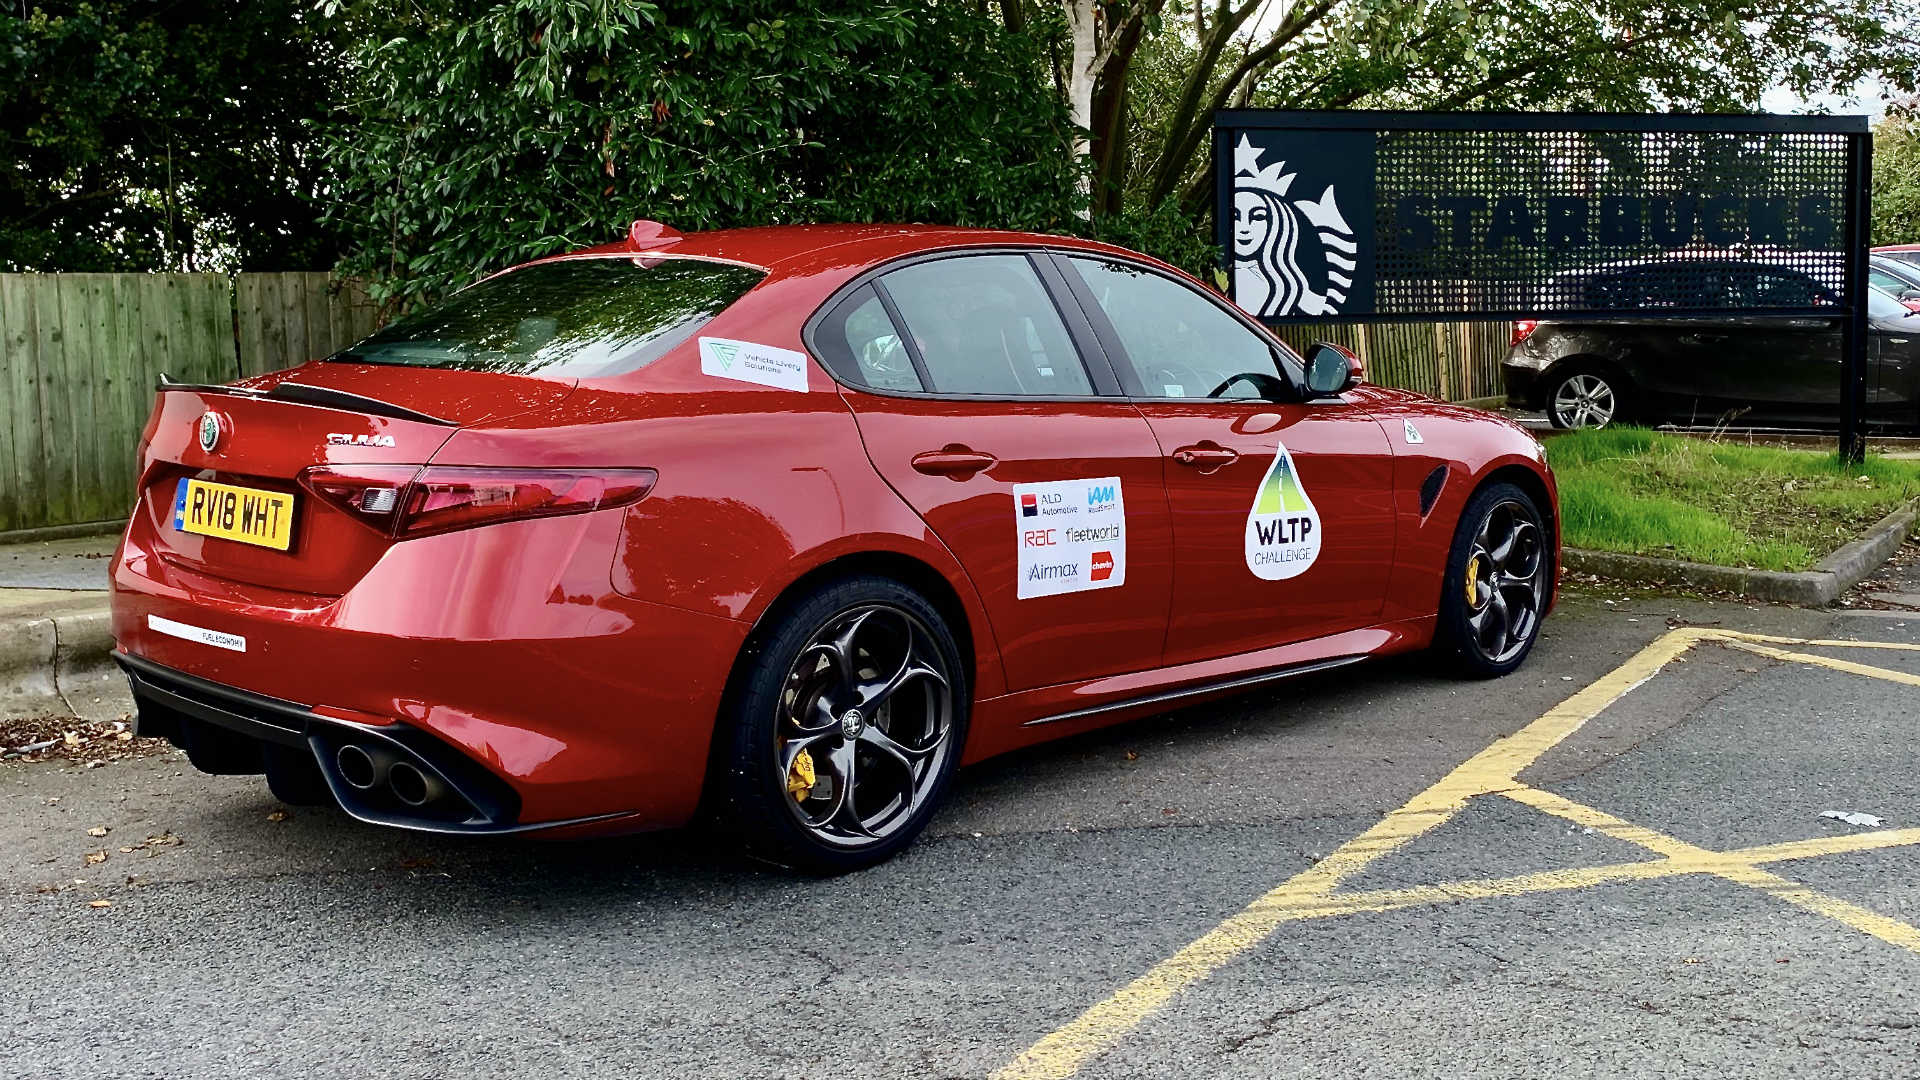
[995,628,1713,1080]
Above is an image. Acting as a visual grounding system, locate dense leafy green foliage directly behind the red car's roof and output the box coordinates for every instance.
[332,0,1077,300]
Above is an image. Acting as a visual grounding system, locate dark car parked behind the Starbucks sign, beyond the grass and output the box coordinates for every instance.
[1505,261,1920,429]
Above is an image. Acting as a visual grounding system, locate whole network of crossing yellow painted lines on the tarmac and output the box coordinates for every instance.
[995,626,1920,1080]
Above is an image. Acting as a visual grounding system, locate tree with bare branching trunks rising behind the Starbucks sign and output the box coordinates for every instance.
[1036,0,1920,245]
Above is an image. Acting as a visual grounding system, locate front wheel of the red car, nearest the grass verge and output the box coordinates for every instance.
[1434,484,1553,678]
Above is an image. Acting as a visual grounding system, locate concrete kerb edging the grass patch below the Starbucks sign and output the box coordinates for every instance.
[1563,500,1920,607]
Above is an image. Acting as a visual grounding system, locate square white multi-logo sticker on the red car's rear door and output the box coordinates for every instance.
[1014,477,1127,600]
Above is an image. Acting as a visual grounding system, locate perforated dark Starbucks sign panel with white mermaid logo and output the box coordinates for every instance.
[1213,110,1866,323]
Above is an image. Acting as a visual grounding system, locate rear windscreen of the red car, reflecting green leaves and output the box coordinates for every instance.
[328,258,766,379]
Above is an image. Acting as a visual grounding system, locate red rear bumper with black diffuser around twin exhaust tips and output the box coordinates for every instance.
[113,511,747,832]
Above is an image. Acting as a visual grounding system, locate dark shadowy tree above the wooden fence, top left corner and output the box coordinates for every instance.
[0,0,338,271]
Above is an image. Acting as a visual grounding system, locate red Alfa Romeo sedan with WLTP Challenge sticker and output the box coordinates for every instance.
[113,221,1559,872]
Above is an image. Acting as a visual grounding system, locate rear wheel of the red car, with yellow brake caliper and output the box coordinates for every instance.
[714,575,972,874]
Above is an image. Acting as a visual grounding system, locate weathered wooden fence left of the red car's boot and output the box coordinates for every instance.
[0,273,374,532]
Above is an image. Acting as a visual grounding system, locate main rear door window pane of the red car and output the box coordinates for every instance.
[875,256,1092,398]
